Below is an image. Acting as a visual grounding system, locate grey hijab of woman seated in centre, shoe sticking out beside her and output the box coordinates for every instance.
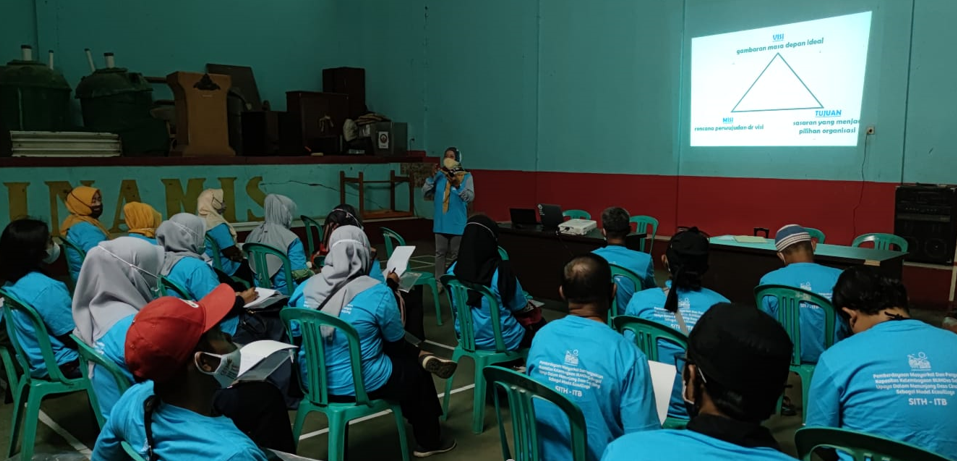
[303,226,379,340]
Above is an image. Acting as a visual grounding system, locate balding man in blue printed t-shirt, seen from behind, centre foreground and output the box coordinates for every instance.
[526,255,661,461]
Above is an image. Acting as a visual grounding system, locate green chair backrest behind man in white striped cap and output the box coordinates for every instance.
[754,285,837,365]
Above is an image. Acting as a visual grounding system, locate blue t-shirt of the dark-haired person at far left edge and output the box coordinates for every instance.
[4,272,79,378]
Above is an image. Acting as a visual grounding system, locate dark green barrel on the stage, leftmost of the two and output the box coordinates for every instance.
[0,60,70,131]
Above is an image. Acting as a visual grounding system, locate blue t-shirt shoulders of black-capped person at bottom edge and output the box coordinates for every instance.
[601,430,794,461]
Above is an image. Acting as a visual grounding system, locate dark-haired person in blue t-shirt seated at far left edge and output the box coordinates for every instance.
[0,219,80,378]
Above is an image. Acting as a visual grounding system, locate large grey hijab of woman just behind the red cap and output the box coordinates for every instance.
[73,237,164,346]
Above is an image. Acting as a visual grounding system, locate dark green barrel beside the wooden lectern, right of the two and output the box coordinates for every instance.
[76,67,169,156]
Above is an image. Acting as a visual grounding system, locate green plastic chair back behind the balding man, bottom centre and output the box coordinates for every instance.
[482,367,588,461]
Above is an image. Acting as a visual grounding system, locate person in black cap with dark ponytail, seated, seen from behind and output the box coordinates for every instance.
[625,227,728,419]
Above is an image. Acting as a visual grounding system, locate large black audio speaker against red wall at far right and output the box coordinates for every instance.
[894,185,957,264]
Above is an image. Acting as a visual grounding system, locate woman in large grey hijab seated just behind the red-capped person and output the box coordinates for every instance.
[73,237,163,417]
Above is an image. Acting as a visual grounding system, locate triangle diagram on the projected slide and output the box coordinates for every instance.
[731,53,824,112]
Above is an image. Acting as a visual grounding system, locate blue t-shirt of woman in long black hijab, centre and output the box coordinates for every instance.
[448,264,528,351]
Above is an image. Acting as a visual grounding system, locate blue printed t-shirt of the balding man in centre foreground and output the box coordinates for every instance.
[525,315,661,461]
